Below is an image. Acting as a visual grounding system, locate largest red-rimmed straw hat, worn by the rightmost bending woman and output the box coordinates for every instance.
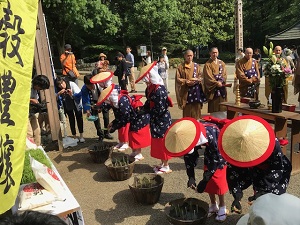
[218,116,275,167]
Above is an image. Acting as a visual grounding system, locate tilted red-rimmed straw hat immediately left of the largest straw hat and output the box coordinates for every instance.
[164,117,207,157]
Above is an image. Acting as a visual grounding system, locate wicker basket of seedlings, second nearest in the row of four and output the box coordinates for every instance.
[129,173,164,205]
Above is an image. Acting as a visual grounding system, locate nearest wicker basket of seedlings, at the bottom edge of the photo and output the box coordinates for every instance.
[165,198,208,225]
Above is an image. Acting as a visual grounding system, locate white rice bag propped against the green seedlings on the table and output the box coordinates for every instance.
[30,157,66,201]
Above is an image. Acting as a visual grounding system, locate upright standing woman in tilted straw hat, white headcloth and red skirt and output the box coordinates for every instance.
[136,61,172,174]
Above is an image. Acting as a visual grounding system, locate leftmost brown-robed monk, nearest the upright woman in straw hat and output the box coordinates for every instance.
[175,50,206,119]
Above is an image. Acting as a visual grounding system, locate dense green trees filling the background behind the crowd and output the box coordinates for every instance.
[43,0,299,61]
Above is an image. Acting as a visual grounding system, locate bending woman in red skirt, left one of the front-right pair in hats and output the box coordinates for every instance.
[164,117,228,222]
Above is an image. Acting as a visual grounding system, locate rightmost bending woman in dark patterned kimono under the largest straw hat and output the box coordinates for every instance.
[218,116,292,213]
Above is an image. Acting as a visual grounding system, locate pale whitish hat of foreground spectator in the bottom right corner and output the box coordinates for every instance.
[236,193,300,225]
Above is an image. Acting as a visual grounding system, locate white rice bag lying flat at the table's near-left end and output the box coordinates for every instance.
[18,183,55,211]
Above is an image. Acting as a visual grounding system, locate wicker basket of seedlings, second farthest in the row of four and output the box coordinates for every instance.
[104,154,135,181]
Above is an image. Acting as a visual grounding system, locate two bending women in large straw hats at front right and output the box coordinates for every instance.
[165,116,292,222]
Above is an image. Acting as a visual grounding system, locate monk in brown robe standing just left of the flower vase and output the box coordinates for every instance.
[235,48,260,100]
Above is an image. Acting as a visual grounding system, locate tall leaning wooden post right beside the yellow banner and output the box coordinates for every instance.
[34,1,63,150]
